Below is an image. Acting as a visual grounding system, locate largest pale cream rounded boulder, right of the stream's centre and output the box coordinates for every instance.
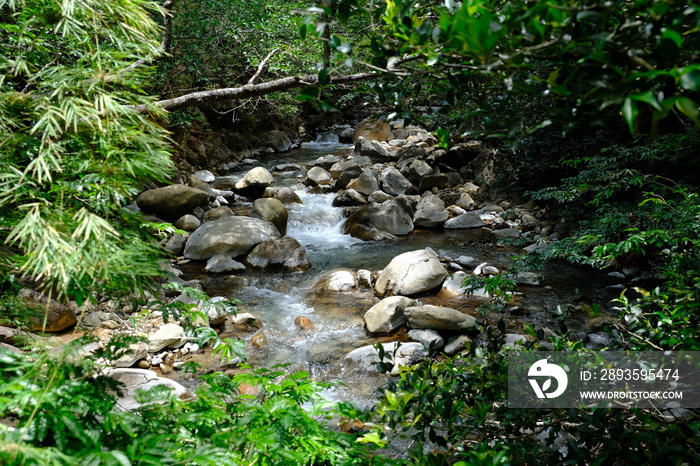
[374,249,447,296]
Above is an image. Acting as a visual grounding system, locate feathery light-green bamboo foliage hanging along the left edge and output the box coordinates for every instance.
[0,0,172,302]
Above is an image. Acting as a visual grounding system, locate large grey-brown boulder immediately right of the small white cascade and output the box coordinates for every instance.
[343,201,413,241]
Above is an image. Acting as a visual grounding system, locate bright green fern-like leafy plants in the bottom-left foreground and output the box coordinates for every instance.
[0,340,382,466]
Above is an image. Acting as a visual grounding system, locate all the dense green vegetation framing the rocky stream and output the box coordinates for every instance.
[0,0,700,465]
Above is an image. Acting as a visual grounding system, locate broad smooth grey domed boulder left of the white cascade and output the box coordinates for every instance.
[184,216,280,260]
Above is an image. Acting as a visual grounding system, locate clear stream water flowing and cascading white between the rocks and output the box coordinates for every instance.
[179,139,603,404]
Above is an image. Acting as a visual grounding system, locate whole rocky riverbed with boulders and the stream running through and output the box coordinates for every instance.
[4,121,653,404]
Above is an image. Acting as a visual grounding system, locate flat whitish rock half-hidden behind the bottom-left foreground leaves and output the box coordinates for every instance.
[106,369,189,411]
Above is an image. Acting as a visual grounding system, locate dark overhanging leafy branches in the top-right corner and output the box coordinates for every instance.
[318,0,700,136]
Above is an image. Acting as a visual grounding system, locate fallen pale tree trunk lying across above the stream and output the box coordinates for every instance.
[134,73,378,113]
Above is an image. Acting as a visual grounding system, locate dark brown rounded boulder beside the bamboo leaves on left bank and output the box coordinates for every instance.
[136,184,209,222]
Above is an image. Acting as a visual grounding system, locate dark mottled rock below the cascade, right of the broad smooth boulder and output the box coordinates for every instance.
[245,236,311,272]
